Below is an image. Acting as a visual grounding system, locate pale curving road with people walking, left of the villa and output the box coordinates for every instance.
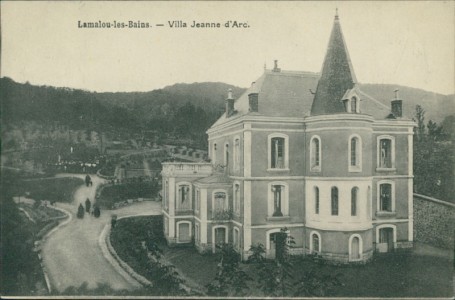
[42,174,161,292]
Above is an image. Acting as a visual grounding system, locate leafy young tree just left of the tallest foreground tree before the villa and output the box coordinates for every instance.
[207,244,252,297]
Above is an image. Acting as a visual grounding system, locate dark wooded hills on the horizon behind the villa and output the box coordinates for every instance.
[0,77,455,139]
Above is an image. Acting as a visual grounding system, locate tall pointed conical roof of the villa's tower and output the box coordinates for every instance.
[311,14,357,115]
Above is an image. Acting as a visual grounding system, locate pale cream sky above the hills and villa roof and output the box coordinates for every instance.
[0,1,455,94]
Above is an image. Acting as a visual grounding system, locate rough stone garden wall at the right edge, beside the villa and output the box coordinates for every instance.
[414,194,455,249]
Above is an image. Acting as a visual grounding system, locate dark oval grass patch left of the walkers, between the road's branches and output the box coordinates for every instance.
[16,177,84,202]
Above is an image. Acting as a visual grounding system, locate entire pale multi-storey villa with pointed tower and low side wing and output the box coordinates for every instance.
[162,16,415,262]
